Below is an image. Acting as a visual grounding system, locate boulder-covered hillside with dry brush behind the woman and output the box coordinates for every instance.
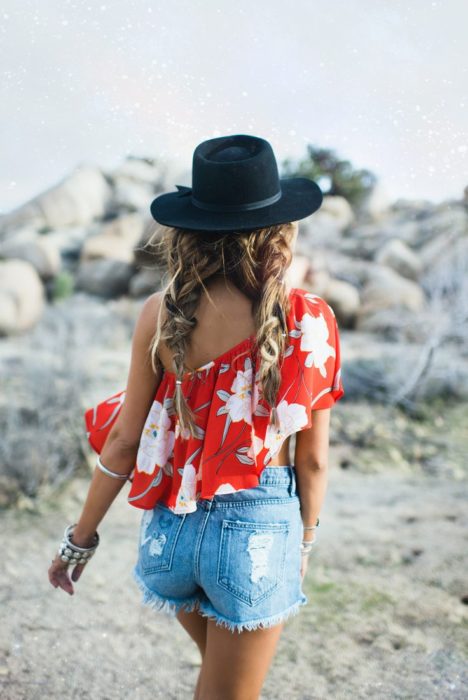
[0,158,468,505]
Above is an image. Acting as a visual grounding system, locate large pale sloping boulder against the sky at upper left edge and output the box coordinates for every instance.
[0,165,112,231]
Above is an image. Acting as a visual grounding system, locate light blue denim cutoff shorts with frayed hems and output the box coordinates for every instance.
[133,465,308,632]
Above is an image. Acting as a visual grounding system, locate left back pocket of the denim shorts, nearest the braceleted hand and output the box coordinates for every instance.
[140,504,185,574]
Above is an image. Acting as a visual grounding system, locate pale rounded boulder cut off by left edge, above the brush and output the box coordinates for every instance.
[0,259,45,335]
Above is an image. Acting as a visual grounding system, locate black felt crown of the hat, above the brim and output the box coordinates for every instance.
[192,134,281,210]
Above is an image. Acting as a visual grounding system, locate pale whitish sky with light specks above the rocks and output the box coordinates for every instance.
[0,0,468,212]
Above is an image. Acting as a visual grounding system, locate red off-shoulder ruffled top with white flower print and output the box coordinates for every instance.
[84,288,344,513]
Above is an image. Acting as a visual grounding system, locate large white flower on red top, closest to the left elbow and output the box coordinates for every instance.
[136,401,175,474]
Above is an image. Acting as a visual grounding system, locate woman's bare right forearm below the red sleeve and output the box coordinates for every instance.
[294,408,331,540]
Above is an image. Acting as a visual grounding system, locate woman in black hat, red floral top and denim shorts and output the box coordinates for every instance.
[49,135,344,700]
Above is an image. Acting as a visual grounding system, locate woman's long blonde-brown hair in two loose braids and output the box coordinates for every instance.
[147,223,293,436]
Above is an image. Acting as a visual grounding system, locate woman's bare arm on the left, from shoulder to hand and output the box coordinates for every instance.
[49,292,162,594]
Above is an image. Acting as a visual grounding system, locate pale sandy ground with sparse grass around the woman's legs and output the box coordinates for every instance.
[0,460,468,700]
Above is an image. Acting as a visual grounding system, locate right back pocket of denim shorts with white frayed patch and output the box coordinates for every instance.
[217,519,289,606]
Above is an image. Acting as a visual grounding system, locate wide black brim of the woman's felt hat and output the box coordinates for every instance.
[150,177,323,231]
